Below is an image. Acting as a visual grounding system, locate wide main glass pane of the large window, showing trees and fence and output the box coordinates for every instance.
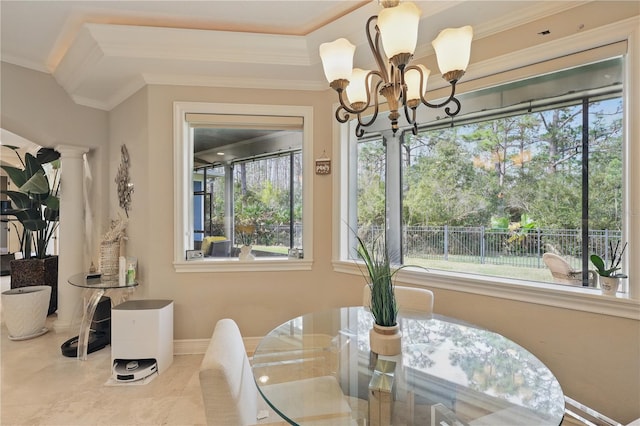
[402,96,624,285]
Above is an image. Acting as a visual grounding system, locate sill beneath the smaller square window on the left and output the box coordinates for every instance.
[173,257,313,272]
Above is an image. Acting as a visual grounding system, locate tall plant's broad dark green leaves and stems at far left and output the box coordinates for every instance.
[2,145,60,259]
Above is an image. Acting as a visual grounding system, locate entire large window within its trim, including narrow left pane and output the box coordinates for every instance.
[349,58,626,291]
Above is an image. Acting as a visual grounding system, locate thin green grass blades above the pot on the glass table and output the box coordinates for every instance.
[356,236,402,327]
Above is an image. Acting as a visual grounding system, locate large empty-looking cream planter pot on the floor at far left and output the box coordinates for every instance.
[2,285,51,340]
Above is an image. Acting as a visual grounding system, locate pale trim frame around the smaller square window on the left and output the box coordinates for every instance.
[173,102,313,272]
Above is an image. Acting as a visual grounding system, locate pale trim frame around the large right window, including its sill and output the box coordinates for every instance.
[332,17,640,321]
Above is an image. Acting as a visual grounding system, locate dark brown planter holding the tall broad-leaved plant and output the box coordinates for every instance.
[11,256,58,315]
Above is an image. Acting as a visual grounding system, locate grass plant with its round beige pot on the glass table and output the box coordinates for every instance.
[356,236,403,355]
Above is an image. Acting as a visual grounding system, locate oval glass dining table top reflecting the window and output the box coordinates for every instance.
[252,307,564,426]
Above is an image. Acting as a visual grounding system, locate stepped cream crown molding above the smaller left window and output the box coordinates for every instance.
[53,24,326,110]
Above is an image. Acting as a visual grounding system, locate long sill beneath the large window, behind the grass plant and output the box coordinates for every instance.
[333,261,640,321]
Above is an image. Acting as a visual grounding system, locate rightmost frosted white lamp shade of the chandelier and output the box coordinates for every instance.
[431,25,473,75]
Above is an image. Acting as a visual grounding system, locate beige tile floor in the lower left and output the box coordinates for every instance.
[0,277,206,426]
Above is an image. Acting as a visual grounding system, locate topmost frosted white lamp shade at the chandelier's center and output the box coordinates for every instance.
[378,2,422,58]
